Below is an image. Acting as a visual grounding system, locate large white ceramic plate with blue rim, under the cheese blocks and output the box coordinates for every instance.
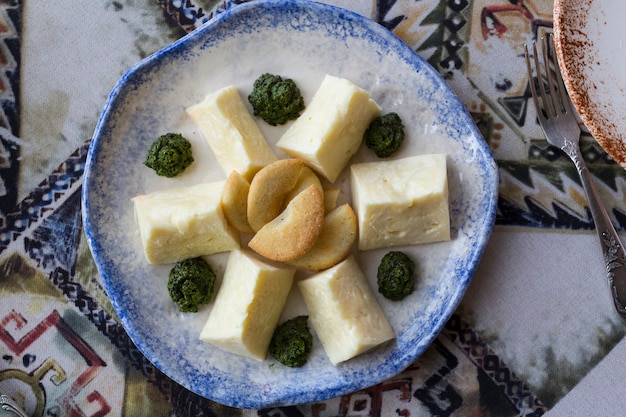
[83,0,498,408]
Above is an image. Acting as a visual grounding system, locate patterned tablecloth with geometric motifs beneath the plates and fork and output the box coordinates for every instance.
[0,0,626,417]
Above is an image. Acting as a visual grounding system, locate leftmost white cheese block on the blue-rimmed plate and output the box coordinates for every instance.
[132,181,239,264]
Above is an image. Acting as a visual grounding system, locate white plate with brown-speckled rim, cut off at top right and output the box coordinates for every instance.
[554,0,626,168]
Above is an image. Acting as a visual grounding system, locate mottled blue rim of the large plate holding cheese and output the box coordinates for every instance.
[82,0,498,409]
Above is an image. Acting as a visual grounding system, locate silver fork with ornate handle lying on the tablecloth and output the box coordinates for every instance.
[524,34,626,319]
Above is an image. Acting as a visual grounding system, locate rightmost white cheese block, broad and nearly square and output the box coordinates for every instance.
[351,154,450,250]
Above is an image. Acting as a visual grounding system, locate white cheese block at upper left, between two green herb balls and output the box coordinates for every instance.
[187,86,277,181]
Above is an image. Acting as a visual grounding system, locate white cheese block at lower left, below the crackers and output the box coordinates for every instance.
[200,250,295,361]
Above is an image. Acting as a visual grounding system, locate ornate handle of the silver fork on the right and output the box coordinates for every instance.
[561,140,626,319]
